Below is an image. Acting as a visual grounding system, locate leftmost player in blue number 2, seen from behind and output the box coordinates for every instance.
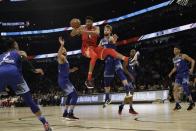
[0,39,52,131]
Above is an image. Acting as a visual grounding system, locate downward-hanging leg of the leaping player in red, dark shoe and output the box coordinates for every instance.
[84,47,98,88]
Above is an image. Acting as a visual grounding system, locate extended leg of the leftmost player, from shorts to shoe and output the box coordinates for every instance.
[10,76,52,131]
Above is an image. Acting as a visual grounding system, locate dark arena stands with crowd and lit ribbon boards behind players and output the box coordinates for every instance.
[0,0,196,106]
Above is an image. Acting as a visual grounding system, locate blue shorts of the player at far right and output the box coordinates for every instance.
[175,73,189,86]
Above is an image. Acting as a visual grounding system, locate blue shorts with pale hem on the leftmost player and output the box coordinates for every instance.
[0,65,30,95]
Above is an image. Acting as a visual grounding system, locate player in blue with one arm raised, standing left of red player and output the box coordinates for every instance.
[57,37,79,120]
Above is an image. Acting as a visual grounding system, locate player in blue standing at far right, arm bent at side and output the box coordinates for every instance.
[169,46,195,110]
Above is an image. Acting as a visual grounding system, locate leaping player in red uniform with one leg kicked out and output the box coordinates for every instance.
[71,17,128,88]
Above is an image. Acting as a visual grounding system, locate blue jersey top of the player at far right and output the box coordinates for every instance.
[173,55,189,74]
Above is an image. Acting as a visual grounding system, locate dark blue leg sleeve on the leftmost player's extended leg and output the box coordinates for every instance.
[21,92,40,113]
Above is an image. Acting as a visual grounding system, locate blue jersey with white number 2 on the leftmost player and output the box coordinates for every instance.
[0,50,22,73]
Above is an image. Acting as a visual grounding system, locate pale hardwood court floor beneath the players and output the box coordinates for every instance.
[0,103,196,131]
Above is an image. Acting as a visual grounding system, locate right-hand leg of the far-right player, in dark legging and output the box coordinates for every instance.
[182,75,195,110]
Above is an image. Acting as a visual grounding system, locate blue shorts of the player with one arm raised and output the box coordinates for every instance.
[58,78,75,95]
